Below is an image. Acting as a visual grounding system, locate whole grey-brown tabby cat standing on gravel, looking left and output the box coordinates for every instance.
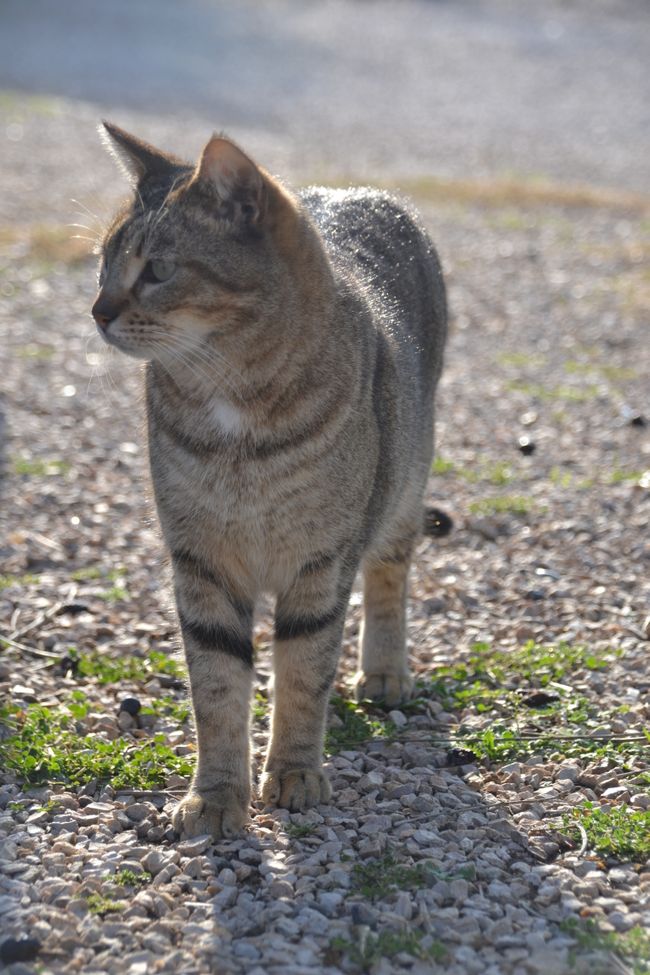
[92,122,447,838]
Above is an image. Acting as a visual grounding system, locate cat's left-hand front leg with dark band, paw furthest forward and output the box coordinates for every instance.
[172,556,253,839]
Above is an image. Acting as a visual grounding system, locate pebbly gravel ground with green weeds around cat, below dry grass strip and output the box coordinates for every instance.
[0,87,650,975]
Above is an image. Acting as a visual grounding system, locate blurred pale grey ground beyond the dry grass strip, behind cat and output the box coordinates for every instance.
[0,0,650,225]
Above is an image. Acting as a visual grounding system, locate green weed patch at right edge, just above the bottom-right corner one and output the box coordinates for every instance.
[562,804,650,863]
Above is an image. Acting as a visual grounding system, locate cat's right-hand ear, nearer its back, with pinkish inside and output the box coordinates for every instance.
[194,135,266,227]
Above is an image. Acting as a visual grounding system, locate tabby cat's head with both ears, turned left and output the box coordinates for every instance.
[92,122,297,362]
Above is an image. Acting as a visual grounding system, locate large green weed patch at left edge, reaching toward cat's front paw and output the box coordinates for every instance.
[0,692,193,789]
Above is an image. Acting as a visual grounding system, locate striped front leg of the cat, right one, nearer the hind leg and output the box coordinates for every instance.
[261,562,350,811]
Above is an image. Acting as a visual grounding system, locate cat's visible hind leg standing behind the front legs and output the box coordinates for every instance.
[356,535,414,707]
